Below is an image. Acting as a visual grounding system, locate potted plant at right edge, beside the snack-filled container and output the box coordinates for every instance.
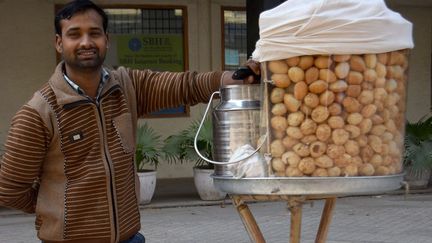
[404,116,432,188]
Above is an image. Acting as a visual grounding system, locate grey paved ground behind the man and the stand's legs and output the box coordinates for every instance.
[0,178,432,243]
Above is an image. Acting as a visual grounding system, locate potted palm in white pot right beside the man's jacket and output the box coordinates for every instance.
[135,123,162,204]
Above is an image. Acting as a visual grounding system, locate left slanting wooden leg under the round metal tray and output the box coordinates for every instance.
[231,195,265,243]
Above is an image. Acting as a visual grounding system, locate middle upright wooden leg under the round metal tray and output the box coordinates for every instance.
[288,197,305,243]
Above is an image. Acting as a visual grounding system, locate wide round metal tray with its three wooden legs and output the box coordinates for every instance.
[213,174,403,243]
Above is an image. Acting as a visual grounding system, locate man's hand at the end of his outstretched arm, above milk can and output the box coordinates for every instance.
[221,59,261,85]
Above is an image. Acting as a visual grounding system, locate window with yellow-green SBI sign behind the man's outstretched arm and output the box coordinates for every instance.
[104,6,189,117]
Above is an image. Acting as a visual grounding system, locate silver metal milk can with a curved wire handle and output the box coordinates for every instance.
[195,84,261,176]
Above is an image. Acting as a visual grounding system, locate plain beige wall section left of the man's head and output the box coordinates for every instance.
[0,0,55,144]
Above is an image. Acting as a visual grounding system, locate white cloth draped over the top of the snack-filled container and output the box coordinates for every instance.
[252,0,414,62]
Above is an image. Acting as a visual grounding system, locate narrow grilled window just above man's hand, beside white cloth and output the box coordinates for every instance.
[224,10,247,70]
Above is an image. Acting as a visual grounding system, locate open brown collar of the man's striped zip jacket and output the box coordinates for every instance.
[49,61,119,106]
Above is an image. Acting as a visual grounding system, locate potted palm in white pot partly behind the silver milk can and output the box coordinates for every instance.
[163,119,226,200]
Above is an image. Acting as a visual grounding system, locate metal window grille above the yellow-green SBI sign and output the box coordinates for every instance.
[105,8,183,34]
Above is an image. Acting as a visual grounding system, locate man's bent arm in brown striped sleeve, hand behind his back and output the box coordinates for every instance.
[0,105,49,213]
